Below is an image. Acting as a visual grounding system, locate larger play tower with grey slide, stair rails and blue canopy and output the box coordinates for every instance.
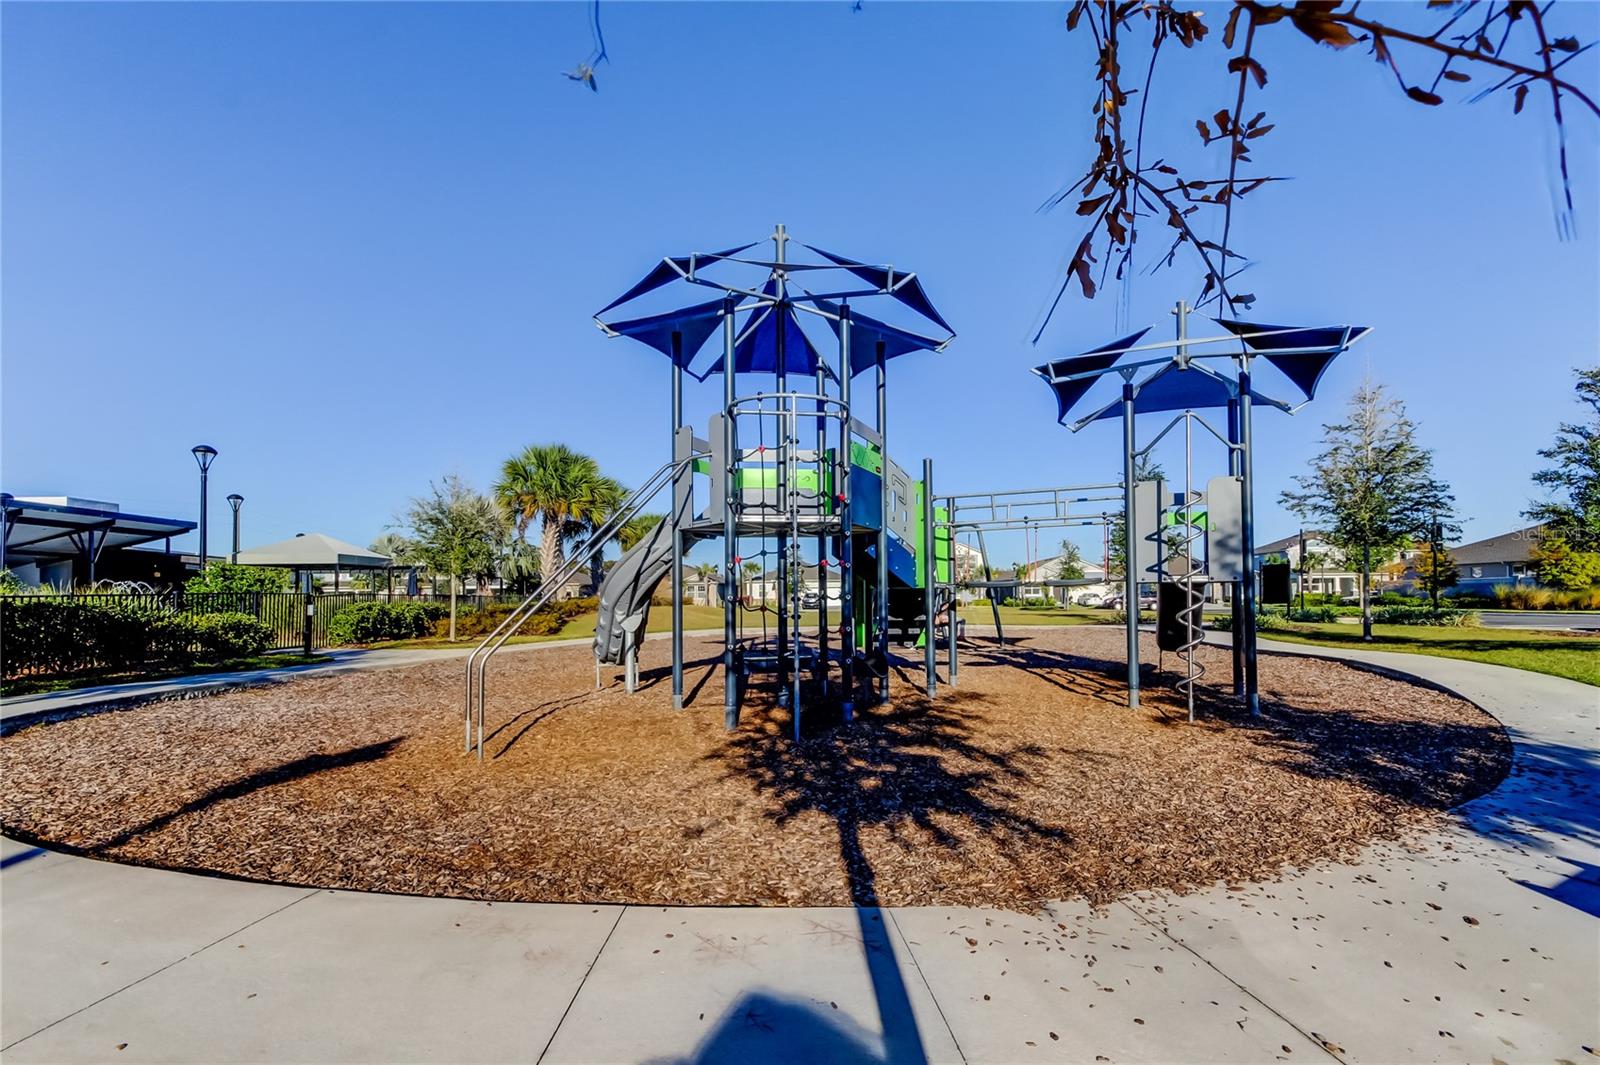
[464,225,954,756]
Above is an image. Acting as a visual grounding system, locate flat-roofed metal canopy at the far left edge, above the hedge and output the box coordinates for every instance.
[0,494,195,584]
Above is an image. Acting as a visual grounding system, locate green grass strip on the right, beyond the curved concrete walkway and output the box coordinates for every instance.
[1261,622,1600,684]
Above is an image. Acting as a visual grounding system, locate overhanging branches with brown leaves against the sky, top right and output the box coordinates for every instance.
[1034,0,1600,332]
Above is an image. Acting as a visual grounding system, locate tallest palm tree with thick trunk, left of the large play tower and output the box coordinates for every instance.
[494,445,624,598]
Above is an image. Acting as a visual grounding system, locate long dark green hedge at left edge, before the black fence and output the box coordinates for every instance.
[0,598,272,676]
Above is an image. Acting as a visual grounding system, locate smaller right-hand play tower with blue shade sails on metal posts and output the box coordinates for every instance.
[1034,302,1370,715]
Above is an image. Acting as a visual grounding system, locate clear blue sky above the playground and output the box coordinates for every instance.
[0,2,1600,569]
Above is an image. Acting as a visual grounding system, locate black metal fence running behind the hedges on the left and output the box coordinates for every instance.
[0,588,522,651]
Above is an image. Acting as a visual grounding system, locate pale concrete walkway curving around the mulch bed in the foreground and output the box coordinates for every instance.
[0,643,1600,1065]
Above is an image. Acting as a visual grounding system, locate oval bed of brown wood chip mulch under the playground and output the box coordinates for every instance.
[0,627,1510,908]
